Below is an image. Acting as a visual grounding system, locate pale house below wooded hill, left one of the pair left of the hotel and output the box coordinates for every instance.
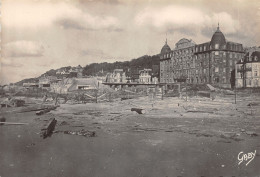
[106,69,127,83]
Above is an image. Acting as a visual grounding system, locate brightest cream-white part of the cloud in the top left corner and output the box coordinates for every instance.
[2,1,79,29]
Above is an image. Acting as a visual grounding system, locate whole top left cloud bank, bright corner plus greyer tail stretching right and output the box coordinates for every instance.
[2,2,119,30]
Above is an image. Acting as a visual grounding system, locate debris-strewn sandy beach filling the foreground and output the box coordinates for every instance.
[0,93,260,177]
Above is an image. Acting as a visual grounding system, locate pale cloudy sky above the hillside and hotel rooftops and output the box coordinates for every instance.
[0,0,260,84]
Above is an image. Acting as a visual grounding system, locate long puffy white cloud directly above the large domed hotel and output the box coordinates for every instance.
[134,5,240,37]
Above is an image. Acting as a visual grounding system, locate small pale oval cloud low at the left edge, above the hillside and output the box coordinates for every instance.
[3,41,44,57]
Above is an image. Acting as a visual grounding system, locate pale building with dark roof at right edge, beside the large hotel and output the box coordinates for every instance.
[235,51,260,88]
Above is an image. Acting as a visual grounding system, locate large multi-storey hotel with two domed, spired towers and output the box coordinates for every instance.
[160,26,244,87]
